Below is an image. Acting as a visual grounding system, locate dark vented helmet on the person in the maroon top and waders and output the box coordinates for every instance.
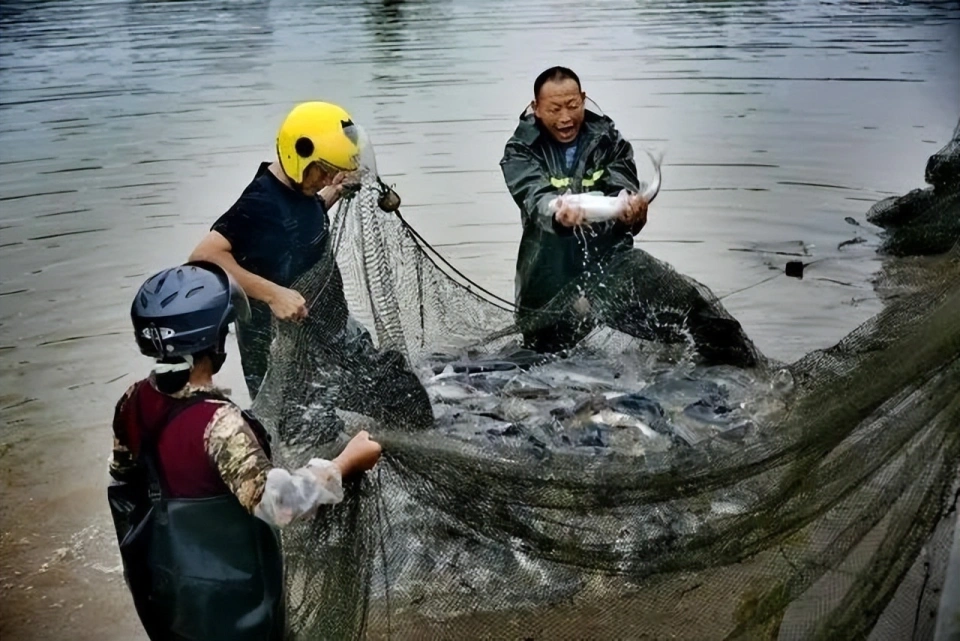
[130,261,250,359]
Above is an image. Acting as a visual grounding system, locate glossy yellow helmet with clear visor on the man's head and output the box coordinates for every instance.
[277,102,360,183]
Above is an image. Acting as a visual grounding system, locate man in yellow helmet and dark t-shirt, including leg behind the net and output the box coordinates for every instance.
[191,102,433,427]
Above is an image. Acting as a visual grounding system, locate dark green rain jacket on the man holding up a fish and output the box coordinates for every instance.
[500,108,643,313]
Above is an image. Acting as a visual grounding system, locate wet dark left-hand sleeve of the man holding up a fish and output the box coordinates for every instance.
[500,140,567,234]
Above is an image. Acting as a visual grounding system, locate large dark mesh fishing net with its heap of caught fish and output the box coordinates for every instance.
[253,121,960,640]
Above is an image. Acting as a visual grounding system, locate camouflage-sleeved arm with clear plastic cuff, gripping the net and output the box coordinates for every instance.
[205,405,379,527]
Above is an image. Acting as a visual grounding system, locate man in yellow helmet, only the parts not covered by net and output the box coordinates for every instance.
[191,102,384,397]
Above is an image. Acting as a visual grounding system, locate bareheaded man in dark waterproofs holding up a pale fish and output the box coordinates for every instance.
[500,67,757,367]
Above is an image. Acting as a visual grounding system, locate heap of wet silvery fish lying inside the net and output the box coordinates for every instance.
[418,344,779,456]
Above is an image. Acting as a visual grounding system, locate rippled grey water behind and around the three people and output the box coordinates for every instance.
[0,0,960,639]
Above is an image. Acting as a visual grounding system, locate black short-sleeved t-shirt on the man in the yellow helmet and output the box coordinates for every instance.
[211,162,330,287]
